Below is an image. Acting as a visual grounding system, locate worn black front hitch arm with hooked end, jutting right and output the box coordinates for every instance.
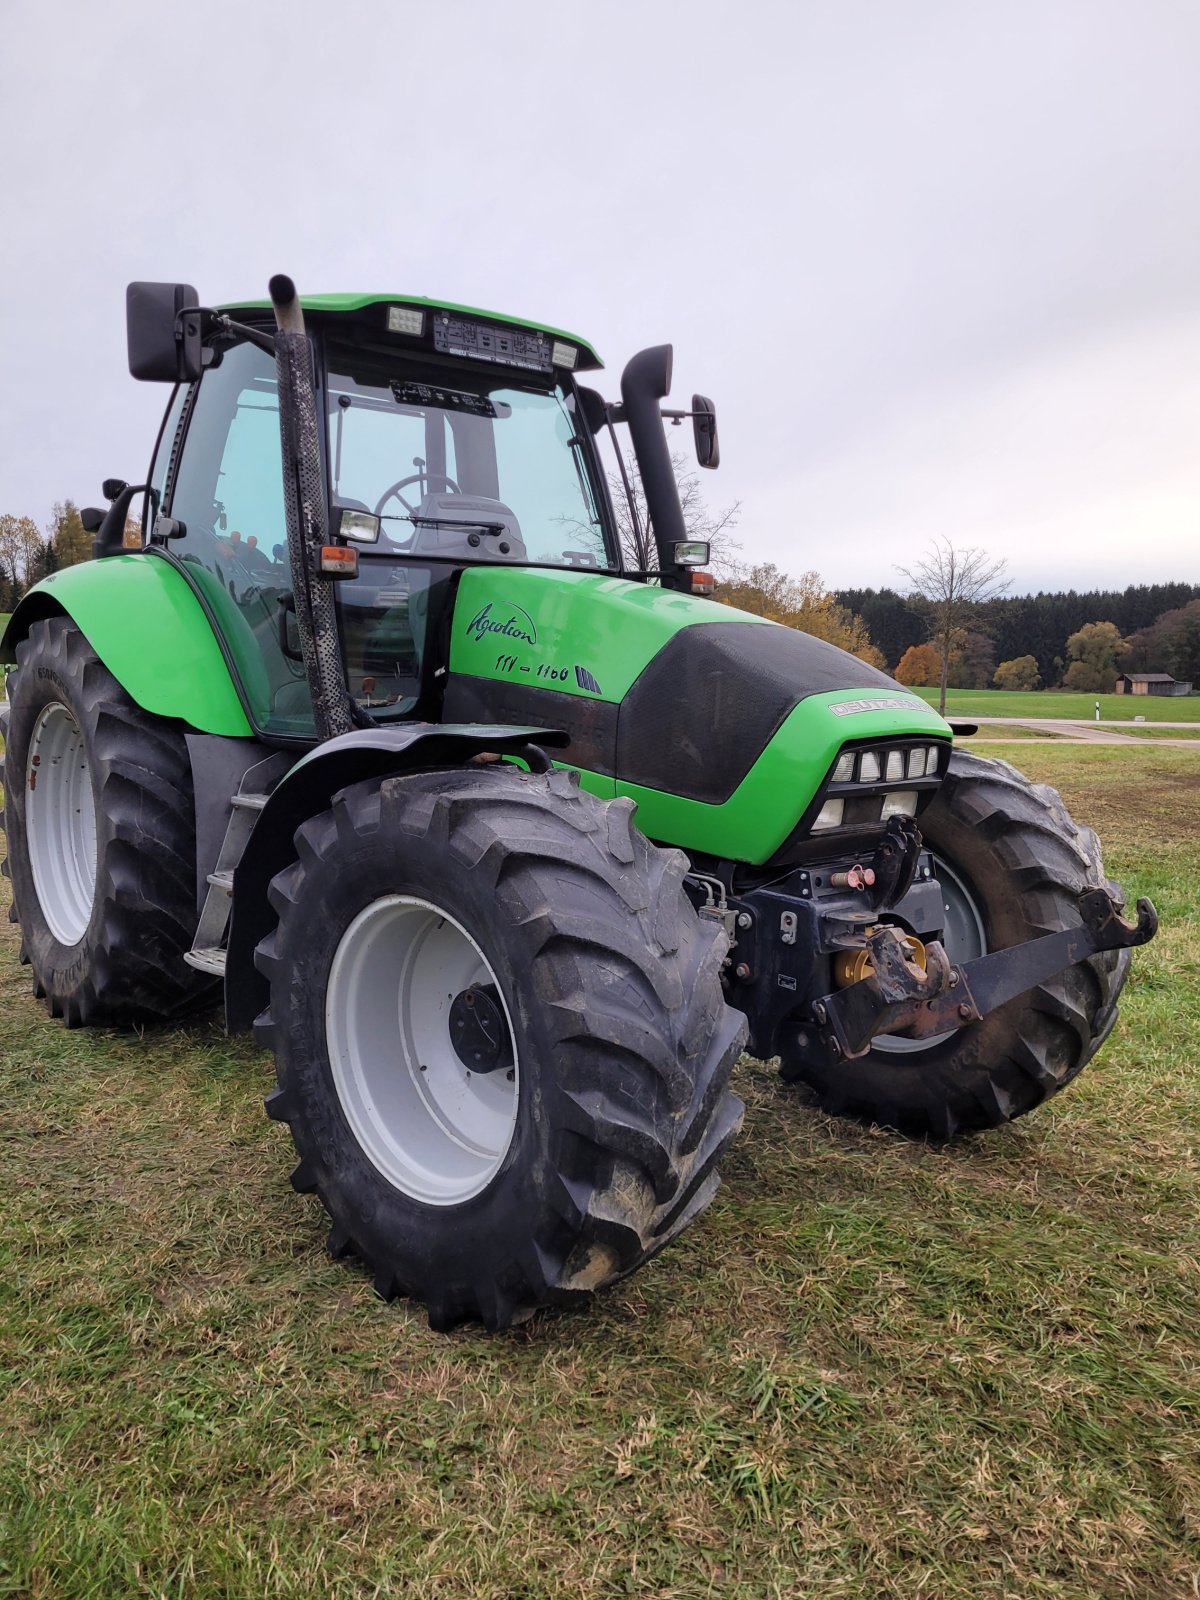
[802,890,1158,1061]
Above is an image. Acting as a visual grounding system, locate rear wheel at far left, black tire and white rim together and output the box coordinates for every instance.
[3,616,214,1027]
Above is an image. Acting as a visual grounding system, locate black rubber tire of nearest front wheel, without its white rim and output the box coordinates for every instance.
[256,766,746,1328]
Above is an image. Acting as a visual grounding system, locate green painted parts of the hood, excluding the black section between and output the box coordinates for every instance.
[450,566,950,864]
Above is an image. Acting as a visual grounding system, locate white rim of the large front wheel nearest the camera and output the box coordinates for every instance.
[325,894,520,1205]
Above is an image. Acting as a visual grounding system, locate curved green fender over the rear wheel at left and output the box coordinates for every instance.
[0,552,251,738]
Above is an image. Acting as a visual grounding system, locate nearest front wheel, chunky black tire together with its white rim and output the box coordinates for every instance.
[256,766,746,1330]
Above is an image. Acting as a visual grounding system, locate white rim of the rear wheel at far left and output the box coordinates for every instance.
[26,701,96,946]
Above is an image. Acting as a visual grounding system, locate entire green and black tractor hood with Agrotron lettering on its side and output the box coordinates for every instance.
[445,566,950,862]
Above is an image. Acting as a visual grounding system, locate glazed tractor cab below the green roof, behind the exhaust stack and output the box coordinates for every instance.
[146,296,621,738]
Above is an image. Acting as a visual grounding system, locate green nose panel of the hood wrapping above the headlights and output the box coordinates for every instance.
[616,690,950,866]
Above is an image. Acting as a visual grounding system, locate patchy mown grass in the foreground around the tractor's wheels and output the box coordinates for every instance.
[0,746,1200,1600]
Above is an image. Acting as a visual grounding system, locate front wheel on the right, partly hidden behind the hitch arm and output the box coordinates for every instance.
[781,750,1130,1139]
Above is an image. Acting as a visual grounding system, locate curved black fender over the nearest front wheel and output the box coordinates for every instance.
[226,722,566,1034]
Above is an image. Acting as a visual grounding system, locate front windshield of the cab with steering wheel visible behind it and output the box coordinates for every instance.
[326,355,619,718]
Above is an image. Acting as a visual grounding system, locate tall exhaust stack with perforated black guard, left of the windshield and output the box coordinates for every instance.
[275,272,357,739]
